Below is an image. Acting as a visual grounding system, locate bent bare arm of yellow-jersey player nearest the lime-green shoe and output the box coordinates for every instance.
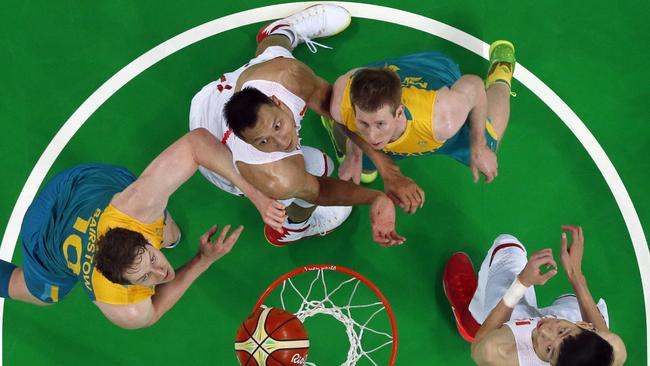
[440,75,498,183]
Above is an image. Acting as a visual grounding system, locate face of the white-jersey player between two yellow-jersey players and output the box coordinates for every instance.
[242,96,299,152]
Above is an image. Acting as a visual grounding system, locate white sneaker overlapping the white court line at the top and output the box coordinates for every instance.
[257,4,352,53]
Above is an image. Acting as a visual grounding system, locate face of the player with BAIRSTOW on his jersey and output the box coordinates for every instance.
[124,245,176,286]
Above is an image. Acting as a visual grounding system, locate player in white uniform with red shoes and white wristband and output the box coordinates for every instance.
[443,226,627,366]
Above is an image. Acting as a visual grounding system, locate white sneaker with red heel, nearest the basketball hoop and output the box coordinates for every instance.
[264,206,352,247]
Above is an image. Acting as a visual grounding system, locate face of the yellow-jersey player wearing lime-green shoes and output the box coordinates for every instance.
[354,105,406,150]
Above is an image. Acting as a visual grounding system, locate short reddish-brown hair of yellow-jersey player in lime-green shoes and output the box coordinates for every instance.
[350,68,402,114]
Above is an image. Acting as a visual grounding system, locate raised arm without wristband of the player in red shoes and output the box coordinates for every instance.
[560,225,627,365]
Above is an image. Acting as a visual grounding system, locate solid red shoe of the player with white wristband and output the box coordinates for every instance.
[442,252,481,342]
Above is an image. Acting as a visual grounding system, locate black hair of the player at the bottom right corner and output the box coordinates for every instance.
[555,330,614,366]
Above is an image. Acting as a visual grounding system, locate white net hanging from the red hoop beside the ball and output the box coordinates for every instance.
[265,269,393,366]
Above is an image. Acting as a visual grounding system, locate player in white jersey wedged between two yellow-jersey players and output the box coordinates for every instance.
[190,4,404,246]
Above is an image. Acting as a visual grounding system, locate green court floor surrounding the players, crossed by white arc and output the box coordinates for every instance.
[0,0,650,366]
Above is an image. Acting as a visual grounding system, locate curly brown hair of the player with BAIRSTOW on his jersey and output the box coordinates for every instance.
[95,228,149,285]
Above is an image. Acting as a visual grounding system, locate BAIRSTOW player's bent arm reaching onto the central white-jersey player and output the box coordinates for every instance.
[112,128,284,229]
